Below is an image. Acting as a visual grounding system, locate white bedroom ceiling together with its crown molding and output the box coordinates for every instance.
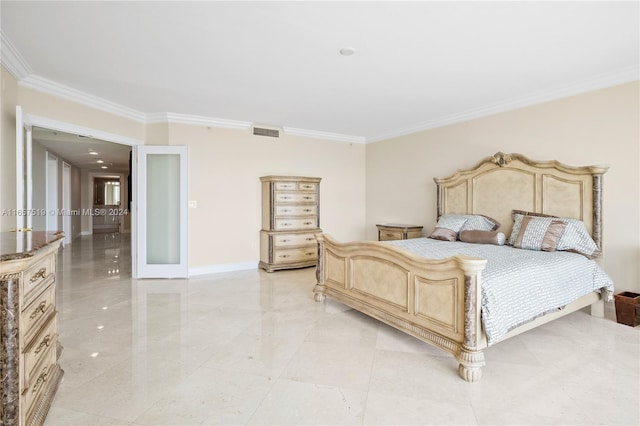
[0,0,640,142]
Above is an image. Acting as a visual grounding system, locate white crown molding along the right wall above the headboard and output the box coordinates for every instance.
[367,66,640,143]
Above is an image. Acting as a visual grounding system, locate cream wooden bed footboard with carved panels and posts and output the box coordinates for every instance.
[313,234,486,382]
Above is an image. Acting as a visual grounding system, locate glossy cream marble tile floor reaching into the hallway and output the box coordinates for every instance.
[45,234,640,426]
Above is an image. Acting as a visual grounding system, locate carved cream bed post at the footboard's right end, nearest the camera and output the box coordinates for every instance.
[456,259,486,382]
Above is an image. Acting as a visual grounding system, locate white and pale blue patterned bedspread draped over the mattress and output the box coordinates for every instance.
[387,238,613,346]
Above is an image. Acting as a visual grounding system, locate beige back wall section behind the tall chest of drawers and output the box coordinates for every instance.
[169,124,365,267]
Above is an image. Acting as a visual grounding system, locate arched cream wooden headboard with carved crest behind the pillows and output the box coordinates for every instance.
[434,152,609,249]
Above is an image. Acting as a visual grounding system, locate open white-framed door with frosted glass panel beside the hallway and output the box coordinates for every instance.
[133,145,189,278]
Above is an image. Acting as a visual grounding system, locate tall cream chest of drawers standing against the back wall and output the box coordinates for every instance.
[260,176,321,272]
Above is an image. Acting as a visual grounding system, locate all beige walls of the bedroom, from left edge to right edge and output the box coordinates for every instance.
[0,62,640,291]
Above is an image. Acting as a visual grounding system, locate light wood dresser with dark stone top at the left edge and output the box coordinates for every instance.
[0,231,63,426]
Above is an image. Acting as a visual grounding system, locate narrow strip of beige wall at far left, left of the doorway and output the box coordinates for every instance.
[0,67,18,231]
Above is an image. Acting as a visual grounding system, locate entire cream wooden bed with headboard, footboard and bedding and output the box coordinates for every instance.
[313,152,613,382]
